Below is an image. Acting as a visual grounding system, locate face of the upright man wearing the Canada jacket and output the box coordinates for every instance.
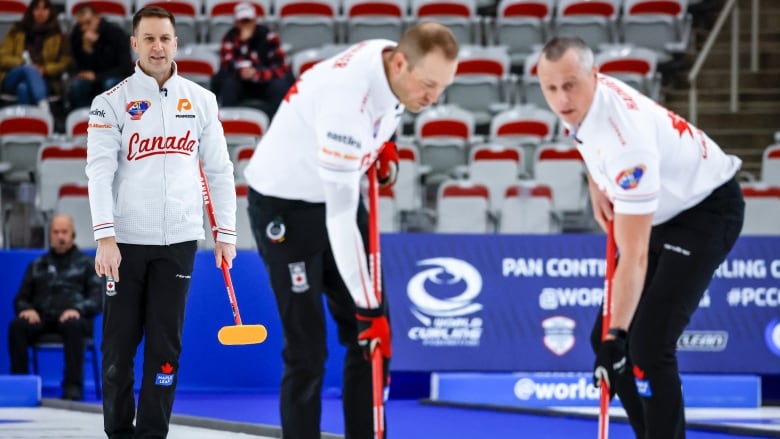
[130,17,177,82]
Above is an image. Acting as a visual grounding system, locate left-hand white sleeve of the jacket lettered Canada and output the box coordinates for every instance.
[85,95,122,240]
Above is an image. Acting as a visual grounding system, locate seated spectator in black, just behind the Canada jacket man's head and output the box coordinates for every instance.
[69,3,133,108]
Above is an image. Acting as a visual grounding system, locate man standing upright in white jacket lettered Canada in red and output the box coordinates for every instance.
[86,6,236,438]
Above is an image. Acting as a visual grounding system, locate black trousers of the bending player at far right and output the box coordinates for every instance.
[591,179,745,439]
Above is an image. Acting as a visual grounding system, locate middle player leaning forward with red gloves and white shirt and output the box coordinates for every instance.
[245,23,458,439]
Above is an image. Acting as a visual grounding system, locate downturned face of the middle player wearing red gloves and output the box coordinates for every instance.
[390,50,458,113]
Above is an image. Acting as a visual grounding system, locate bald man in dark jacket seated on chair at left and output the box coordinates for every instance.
[8,215,104,400]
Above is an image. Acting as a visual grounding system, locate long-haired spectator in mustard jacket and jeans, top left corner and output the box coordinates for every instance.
[0,0,70,111]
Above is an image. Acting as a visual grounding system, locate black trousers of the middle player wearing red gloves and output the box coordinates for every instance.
[248,190,388,439]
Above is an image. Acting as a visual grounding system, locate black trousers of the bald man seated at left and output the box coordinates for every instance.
[8,317,92,389]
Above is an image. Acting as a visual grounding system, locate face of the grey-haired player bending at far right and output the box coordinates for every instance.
[536,49,597,125]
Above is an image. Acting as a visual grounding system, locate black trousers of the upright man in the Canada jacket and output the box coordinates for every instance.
[101,241,197,439]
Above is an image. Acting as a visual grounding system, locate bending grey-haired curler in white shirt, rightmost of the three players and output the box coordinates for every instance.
[537,37,745,439]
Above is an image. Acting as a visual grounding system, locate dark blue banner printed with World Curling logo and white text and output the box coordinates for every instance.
[382,234,780,373]
